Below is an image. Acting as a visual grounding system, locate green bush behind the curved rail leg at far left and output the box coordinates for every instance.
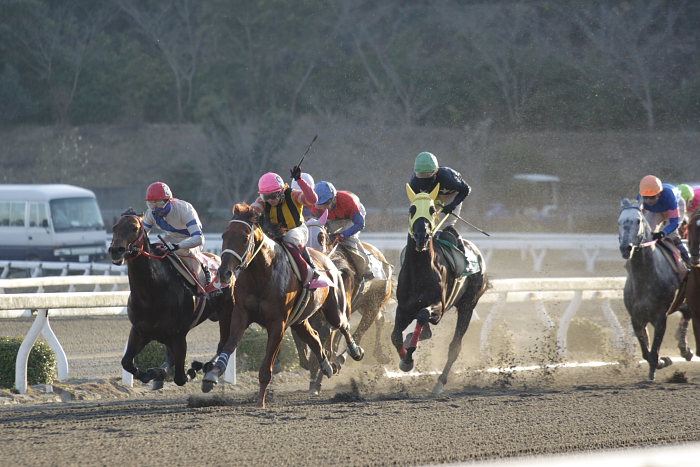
[0,337,56,388]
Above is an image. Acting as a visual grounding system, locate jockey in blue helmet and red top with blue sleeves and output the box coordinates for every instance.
[314,182,374,281]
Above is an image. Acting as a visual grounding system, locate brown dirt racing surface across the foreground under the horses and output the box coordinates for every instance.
[0,362,700,465]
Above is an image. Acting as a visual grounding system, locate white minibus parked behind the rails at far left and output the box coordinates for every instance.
[0,185,106,261]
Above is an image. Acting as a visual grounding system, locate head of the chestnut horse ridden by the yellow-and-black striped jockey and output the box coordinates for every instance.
[219,203,263,284]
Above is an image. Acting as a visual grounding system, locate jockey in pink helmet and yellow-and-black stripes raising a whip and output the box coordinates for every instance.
[251,166,331,289]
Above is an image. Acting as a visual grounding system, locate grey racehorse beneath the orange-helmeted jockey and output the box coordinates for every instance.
[617,198,692,380]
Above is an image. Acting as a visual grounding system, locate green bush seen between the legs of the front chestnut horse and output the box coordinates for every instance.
[236,325,299,371]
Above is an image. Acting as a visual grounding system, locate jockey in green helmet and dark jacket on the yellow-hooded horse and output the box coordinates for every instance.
[409,152,471,249]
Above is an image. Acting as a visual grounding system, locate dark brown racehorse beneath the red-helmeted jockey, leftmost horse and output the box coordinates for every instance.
[108,209,233,389]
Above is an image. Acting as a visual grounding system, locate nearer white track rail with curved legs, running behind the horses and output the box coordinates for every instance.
[0,276,635,394]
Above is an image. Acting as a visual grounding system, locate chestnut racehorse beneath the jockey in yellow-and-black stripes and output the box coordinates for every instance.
[202,203,364,407]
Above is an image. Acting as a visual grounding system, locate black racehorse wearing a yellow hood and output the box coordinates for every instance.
[391,184,488,394]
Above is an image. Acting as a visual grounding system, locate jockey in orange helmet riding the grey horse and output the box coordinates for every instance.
[637,175,690,264]
